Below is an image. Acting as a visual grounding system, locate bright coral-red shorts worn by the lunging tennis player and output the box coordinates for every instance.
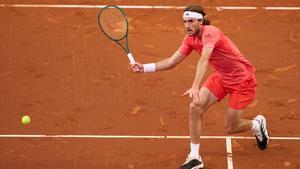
[203,73,257,110]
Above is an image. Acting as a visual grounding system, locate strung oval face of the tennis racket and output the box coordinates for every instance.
[99,8,128,40]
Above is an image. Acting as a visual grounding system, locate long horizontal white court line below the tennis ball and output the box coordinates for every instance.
[0,134,300,140]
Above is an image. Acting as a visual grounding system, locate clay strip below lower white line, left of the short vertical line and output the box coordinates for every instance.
[0,139,227,169]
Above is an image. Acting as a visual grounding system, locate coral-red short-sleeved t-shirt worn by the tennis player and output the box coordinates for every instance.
[178,25,255,85]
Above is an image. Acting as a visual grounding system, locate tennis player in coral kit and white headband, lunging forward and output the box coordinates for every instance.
[130,5,269,169]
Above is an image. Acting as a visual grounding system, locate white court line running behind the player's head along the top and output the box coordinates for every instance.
[0,4,300,11]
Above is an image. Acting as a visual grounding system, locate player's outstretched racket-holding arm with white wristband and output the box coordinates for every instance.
[129,51,186,72]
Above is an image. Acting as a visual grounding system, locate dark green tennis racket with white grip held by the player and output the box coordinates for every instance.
[98,5,135,63]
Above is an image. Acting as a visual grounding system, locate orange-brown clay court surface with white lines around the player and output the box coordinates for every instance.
[0,0,300,169]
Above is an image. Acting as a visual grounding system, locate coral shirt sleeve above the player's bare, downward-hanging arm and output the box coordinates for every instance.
[202,28,220,47]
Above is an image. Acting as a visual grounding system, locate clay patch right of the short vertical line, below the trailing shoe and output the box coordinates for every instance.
[233,140,300,169]
